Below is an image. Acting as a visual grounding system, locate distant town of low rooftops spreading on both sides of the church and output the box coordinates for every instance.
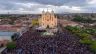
[0,13,96,31]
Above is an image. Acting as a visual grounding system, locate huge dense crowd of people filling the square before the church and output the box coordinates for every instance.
[4,28,96,54]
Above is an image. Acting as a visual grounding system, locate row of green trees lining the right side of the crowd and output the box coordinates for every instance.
[65,26,96,51]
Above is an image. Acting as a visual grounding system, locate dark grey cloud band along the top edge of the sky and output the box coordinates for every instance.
[14,0,87,6]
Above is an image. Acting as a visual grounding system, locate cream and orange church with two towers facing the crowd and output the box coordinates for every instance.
[39,10,57,28]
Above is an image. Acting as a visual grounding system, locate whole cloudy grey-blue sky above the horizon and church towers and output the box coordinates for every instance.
[0,0,96,14]
